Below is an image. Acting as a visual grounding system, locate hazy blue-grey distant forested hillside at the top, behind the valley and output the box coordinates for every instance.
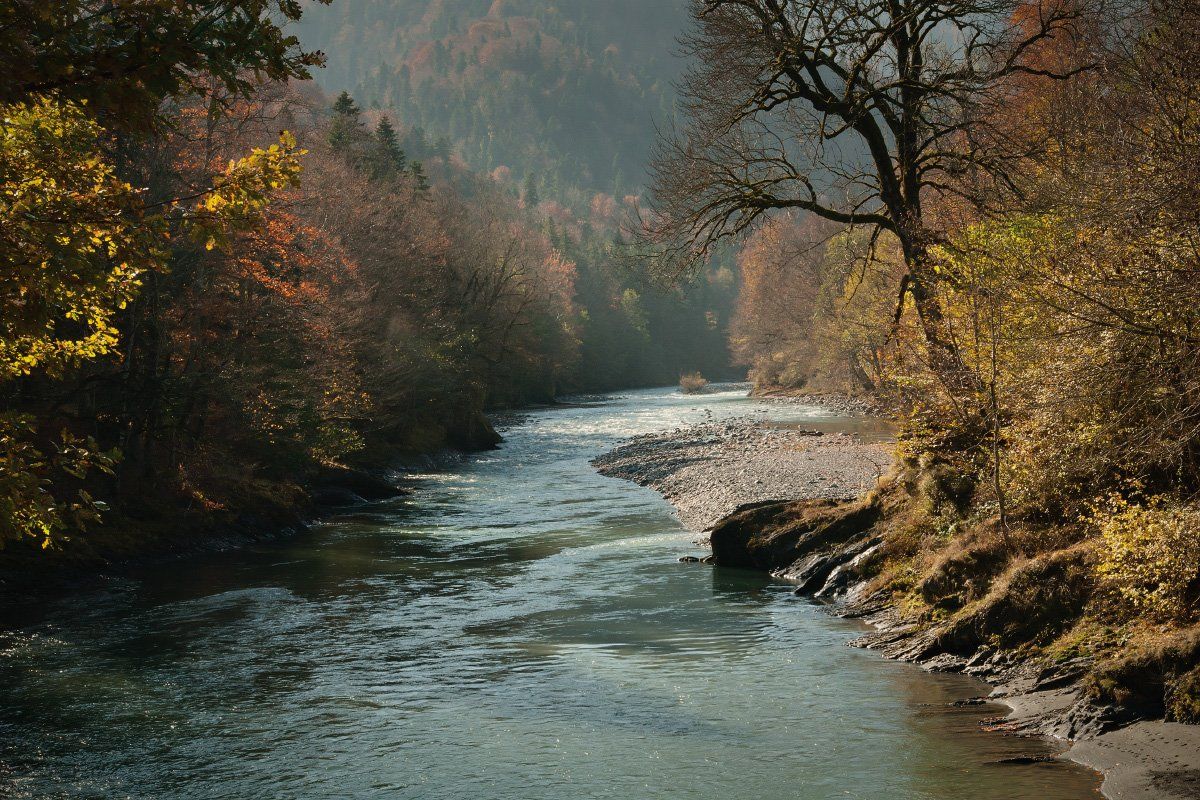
[299,0,686,199]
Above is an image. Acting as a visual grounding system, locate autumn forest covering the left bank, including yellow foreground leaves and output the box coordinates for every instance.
[0,0,736,558]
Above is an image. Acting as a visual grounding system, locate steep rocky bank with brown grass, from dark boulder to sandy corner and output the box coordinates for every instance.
[710,482,1200,800]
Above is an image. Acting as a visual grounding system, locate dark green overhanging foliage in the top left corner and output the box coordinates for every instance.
[0,0,329,128]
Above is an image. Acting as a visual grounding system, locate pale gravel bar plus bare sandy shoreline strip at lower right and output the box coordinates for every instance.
[593,410,1200,800]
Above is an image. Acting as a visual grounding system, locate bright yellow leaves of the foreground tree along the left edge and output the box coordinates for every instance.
[0,100,299,545]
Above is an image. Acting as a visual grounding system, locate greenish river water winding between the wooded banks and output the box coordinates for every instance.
[0,390,1097,800]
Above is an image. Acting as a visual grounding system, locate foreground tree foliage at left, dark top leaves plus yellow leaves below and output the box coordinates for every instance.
[0,0,320,546]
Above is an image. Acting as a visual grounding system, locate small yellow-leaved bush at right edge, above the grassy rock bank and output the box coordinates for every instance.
[1092,498,1200,618]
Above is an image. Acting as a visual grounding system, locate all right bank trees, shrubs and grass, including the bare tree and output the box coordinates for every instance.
[642,0,1200,722]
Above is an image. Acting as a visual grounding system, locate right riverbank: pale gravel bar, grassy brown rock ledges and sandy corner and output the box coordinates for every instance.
[594,410,1200,800]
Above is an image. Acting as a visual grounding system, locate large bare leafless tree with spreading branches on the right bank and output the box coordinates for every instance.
[643,0,1087,377]
